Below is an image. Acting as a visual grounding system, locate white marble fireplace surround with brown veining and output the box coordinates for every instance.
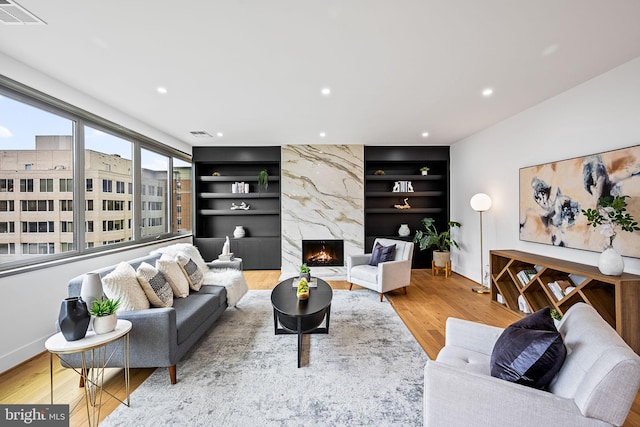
[280,145,364,280]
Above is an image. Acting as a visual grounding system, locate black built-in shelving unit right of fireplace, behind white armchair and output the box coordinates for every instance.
[364,146,449,268]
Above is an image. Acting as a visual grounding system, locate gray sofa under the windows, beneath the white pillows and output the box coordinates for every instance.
[65,253,227,384]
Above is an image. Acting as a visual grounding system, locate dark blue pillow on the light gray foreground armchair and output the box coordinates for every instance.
[491,307,567,390]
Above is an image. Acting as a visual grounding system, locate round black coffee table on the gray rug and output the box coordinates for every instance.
[271,277,333,368]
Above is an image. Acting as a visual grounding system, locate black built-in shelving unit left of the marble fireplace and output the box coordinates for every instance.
[193,147,281,270]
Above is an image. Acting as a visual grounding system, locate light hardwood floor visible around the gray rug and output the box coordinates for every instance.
[0,270,640,426]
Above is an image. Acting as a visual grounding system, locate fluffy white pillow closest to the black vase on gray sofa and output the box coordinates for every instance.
[102,261,149,311]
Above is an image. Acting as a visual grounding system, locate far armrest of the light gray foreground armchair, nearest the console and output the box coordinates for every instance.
[445,317,504,356]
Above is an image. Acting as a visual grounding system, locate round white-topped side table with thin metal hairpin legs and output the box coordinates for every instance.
[44,319,131,426]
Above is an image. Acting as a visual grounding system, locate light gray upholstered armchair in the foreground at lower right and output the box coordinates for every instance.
[424,303,640,427]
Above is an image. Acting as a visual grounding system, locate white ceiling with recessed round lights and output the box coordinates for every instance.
[0,0,640,145]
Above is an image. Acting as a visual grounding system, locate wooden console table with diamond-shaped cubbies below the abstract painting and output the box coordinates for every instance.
[490,250,640,354]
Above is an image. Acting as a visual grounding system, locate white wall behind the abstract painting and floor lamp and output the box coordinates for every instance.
[451,58,640,282]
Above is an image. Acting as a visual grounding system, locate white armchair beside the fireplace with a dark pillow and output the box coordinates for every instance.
[347,239,413,302]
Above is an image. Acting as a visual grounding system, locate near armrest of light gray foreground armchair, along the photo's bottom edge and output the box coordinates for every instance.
[424,361,609,427]
